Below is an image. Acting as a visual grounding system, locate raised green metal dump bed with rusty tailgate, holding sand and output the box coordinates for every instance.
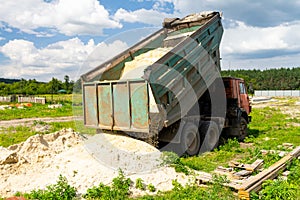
[82,12,223,142]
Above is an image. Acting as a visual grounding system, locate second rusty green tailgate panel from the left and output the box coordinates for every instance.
[97,83,113,127]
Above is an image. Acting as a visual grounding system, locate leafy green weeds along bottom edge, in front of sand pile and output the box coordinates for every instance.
[16,171,236,200]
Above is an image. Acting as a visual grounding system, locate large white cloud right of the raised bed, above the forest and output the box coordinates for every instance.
[221,21,300,69]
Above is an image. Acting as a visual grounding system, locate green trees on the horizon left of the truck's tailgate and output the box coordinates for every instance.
[0,75,80,96]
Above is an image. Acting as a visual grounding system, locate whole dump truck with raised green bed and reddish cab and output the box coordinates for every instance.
[81,12,251,155]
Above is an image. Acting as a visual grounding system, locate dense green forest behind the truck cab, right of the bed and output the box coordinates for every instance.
[221,67,300,92]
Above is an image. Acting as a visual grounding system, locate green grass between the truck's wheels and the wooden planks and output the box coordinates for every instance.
[181,107,300,172]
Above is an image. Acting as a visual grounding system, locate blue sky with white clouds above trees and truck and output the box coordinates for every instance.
[0,0,300,81]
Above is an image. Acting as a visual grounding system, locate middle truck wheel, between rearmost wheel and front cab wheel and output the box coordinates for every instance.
[200,121,220,152]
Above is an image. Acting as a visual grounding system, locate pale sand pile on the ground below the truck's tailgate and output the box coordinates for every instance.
[0,129,188,197]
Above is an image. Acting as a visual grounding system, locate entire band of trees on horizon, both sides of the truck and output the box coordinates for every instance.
[0,67,300,96]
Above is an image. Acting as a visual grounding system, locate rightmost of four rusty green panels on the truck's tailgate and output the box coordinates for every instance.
[130,82,149,129]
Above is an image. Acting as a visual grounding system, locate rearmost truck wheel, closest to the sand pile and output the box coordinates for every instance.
[180,122,201,156]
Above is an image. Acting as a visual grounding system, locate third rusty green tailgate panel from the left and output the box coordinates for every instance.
[113,82,130,129]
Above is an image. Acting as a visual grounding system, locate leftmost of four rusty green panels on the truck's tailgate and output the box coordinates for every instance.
[83,84,98,126]
